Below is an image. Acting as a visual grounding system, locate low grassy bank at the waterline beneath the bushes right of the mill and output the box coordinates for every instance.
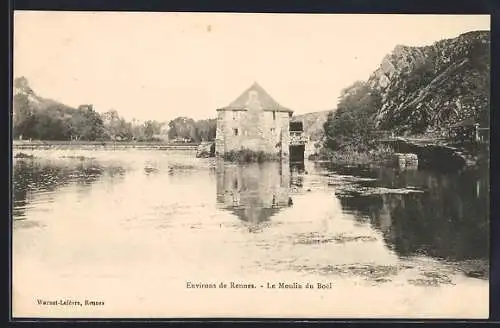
[309,146,394,165]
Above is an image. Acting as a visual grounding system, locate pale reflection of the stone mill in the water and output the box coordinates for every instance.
[217,161,291,227]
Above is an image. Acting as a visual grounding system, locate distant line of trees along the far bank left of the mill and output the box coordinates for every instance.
[12,77,216,142]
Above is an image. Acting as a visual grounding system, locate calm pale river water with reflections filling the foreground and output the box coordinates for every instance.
[12,149,489,318]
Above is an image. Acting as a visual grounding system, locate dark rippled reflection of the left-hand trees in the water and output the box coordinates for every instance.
[12,160,125,218]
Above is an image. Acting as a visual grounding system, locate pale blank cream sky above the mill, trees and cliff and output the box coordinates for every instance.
[13,11,490,121]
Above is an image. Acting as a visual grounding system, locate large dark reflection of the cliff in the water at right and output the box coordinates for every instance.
[340,169,489,260]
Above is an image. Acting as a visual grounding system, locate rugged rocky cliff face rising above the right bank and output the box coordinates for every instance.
[368,31,490,133]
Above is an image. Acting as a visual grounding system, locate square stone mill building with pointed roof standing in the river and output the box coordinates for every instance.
[215,83,305,159]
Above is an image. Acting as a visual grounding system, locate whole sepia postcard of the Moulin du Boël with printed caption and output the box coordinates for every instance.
[10,11,491,319]
